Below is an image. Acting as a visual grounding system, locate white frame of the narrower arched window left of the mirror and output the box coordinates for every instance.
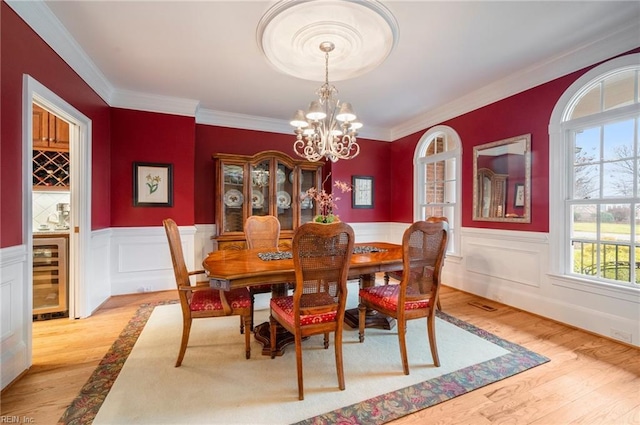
[413,125,462,256]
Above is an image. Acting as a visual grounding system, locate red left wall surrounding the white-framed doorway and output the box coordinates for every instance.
[0,2,111,248]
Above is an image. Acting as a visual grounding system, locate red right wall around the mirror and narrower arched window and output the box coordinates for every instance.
[390,49,640,232]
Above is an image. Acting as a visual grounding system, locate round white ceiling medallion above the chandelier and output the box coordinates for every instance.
[256,0,398,81]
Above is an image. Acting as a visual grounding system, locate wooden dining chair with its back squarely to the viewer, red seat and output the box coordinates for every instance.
[270,222,354,400]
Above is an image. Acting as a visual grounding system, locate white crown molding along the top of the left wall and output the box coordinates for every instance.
[4,0,114,104]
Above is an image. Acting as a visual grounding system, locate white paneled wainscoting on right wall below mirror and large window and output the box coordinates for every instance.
[443,228,640,346]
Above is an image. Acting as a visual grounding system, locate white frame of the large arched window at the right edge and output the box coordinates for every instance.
[549,53,640,293]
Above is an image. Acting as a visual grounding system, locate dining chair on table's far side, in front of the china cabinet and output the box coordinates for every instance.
[241,215,280,332]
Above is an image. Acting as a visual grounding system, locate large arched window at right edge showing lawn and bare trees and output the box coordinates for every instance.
[549,54,640,289]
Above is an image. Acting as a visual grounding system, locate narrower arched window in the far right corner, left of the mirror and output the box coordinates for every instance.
[413,126,462,255]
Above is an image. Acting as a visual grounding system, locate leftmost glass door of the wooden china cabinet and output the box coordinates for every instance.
[222,164,244,232]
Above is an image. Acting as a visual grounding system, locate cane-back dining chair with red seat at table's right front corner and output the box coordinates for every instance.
[358,217,449,375]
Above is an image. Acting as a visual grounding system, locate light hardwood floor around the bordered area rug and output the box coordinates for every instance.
[0,287,640,425]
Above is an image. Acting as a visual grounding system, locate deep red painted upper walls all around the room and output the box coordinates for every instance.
[0,2,640,248]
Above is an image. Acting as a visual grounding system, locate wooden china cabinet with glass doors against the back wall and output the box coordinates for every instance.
[213,151,322,249]
